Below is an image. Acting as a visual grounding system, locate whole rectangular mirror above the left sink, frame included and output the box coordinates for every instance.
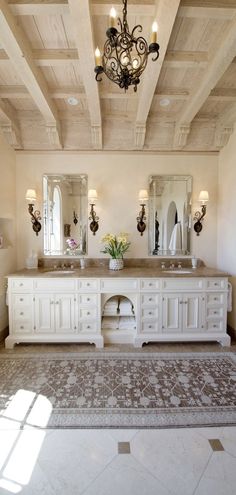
[43,174,88,256]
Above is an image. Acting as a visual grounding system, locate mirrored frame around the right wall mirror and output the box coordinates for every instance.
[148,174,193,257]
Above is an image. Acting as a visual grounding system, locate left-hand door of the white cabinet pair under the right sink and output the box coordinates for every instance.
[162,294,182,333]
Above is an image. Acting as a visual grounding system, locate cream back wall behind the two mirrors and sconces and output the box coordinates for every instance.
[16,152,218,268]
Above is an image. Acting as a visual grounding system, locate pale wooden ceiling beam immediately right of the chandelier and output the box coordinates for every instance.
[134,0,180,149]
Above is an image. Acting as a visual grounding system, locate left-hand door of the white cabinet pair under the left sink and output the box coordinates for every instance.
[35,294,54,334]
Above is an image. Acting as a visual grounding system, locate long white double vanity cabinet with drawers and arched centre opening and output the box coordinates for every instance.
[5,274,230,348]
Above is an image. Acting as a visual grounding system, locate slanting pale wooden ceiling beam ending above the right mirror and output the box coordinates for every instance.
[174,12,236,148]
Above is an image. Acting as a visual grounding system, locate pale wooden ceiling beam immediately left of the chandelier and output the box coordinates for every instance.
[68,0,102,149]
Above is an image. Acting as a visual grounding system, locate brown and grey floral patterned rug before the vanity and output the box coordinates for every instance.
[0,352,236,428]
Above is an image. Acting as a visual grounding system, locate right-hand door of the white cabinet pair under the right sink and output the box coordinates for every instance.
[182,294,204,332]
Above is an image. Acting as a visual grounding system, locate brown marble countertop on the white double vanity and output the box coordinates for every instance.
[7,266,229,278]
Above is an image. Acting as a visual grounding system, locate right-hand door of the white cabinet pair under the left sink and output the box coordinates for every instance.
[54,294,76,334]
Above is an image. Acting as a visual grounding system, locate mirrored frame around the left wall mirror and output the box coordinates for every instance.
[42,173,88,258]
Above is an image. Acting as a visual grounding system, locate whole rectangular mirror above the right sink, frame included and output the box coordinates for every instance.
[149,175,192,256]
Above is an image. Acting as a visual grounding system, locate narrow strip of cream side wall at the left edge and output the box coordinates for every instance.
[0,134,16,334]
